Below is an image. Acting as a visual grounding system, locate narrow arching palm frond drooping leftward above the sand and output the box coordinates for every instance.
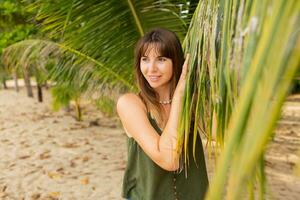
[3,40,133,93]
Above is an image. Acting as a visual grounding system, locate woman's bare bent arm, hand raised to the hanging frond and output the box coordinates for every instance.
[117,56,188,171]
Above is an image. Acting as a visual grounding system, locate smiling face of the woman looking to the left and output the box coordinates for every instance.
[140,45,173,89]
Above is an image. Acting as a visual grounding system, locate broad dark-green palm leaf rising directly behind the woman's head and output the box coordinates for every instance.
[27,0,189,90]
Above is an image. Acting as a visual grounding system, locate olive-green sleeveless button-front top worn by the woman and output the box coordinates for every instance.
[122,115,208,200]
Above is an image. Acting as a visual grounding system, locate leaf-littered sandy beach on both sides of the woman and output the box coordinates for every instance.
[0,83,300,200]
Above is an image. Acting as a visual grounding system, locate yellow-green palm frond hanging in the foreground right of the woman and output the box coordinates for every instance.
[178,0,300,199]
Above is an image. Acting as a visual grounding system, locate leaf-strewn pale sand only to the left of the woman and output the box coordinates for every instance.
[0,90,126,200]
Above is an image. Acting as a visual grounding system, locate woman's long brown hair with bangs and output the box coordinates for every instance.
[135,28,184,124]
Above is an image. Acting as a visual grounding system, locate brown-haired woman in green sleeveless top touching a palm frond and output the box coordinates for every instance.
[117,28,208,200]
